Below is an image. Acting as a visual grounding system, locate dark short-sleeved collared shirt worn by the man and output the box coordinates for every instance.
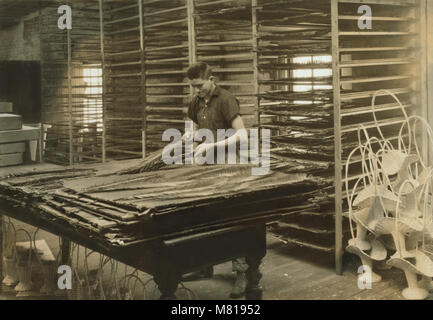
[188,86,240,139]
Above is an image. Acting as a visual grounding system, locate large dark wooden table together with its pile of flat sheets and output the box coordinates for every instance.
[0,160,321,299]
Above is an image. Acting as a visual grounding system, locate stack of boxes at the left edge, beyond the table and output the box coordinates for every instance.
[0,102,40,167]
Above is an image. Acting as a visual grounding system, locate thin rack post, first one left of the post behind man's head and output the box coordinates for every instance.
[138,0,147,159]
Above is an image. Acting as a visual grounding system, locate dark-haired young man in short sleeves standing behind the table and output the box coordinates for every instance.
[183,62,248,298]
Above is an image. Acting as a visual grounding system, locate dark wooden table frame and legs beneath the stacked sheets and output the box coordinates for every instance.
[0,162,274,300]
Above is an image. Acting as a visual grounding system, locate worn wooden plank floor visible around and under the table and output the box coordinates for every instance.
[0,235,432,300]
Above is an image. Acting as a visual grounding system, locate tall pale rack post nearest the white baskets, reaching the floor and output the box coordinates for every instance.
[331,0,343,274]
